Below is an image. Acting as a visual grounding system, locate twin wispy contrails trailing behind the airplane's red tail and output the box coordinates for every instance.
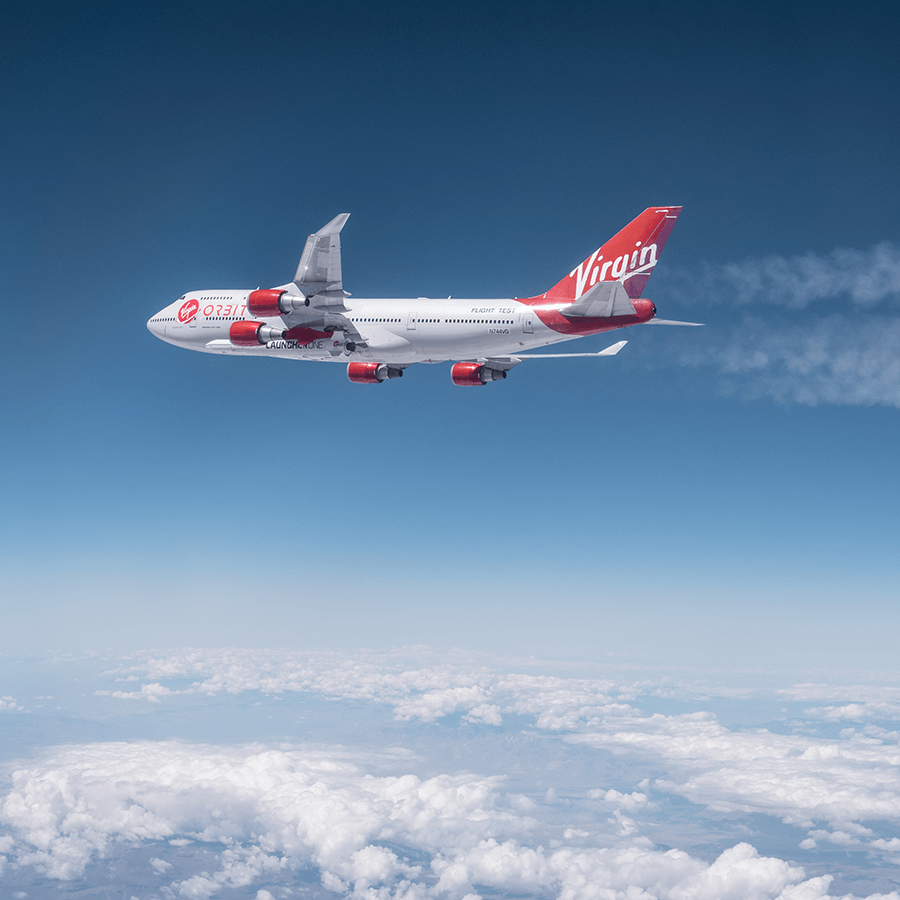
[656,243,900,408]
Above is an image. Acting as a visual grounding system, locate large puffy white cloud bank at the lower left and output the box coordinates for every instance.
[0,743,529,897]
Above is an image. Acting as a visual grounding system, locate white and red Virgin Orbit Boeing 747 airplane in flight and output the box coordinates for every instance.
[147,206,698,387]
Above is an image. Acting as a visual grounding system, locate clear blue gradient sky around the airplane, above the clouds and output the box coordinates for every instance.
[0,2,900,668]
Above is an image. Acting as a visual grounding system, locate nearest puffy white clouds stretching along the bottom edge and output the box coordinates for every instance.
[0,742,880,900]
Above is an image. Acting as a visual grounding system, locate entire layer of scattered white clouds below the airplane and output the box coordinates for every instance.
[0,650,900,900]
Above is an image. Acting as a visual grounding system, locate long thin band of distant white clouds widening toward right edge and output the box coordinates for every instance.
[96,650,900,863]
